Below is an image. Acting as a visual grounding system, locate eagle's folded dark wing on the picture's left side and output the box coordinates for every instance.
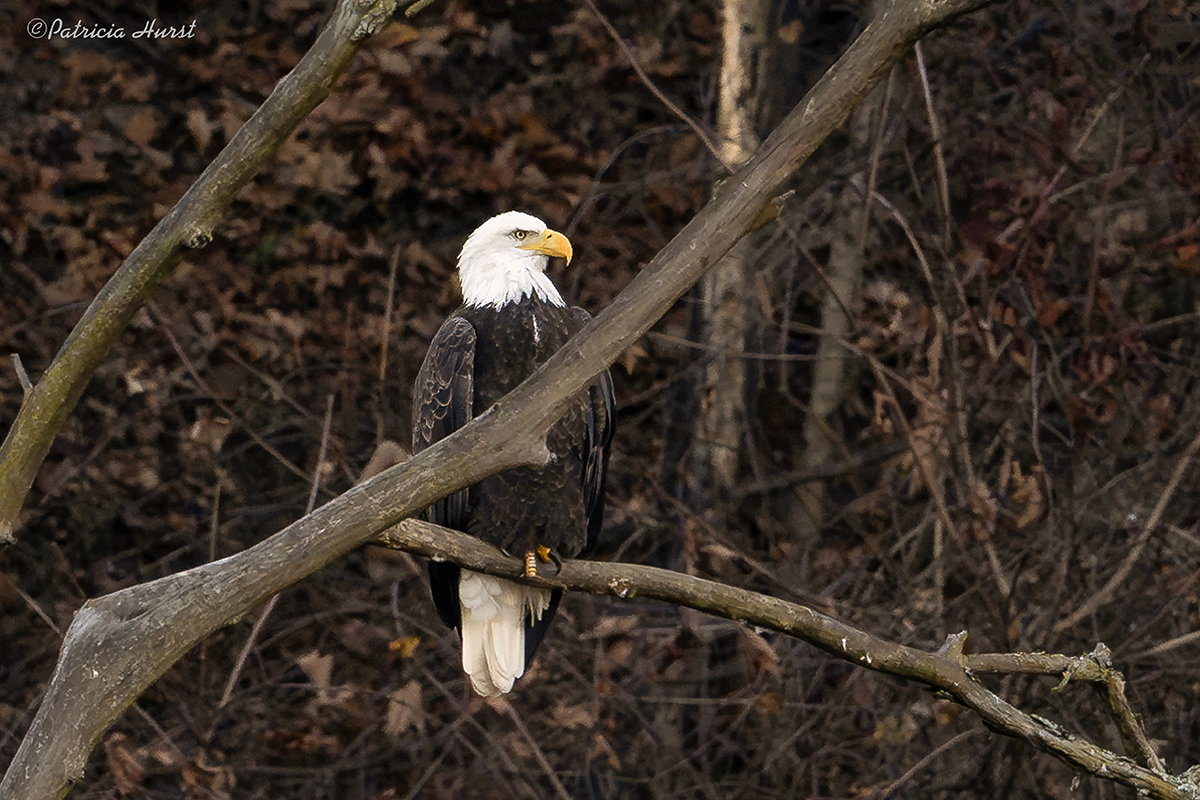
[413,315,475,628]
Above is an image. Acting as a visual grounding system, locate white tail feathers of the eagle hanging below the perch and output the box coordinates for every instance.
[458,570,550,697]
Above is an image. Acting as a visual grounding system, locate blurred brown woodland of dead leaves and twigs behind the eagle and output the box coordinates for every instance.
[0,0,1200,800]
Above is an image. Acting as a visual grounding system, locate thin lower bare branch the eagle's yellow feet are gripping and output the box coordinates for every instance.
[380,519,1198,799]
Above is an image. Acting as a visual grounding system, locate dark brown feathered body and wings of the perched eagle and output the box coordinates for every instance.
[413,295,614,658]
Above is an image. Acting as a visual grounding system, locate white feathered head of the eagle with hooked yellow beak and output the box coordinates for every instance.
[458,211,571,308]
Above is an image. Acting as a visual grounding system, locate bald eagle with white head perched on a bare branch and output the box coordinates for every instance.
[413,211,616,697]
